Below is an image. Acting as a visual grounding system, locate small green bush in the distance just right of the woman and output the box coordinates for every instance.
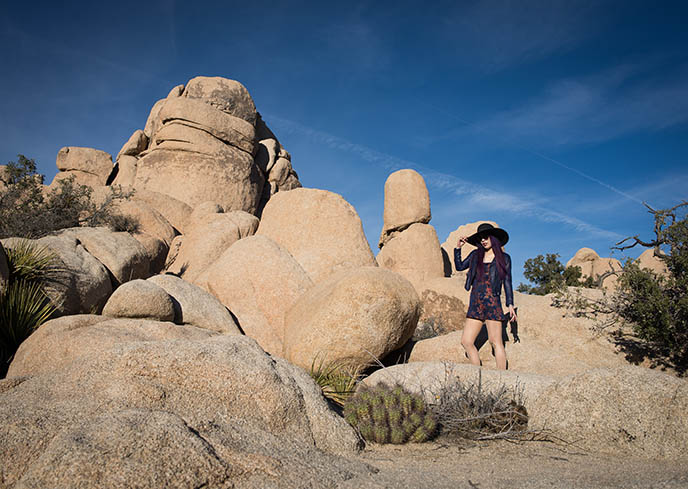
[516,253,595,295]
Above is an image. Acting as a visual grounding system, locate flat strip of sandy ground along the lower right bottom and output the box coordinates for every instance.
[340,441,688,489]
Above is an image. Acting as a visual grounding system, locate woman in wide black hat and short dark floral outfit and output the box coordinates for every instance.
[454,223,516,369]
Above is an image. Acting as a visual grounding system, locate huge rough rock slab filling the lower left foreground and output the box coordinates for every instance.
[0,335,372,488]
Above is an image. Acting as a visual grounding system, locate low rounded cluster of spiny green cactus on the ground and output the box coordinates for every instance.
[344,383,437,444]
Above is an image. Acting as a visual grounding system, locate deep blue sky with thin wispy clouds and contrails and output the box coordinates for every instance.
[0,0,688,285]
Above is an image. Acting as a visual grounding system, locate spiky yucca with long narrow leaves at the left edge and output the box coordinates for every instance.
[0,241,58,378]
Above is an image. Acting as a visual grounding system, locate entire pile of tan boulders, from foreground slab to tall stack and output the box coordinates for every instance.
[0,77,688,488]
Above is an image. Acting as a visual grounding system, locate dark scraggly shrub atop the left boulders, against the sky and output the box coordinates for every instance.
[0,155,138,238]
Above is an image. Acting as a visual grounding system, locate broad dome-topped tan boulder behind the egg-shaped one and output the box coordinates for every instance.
[256,188,376,283]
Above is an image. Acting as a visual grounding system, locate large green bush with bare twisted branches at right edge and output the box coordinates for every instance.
[553,202,688,374]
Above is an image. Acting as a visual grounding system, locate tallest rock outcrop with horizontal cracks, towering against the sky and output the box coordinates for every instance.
[111,77,301,214]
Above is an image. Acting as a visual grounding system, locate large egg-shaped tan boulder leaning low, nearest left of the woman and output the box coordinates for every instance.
[284,267,419,369]
